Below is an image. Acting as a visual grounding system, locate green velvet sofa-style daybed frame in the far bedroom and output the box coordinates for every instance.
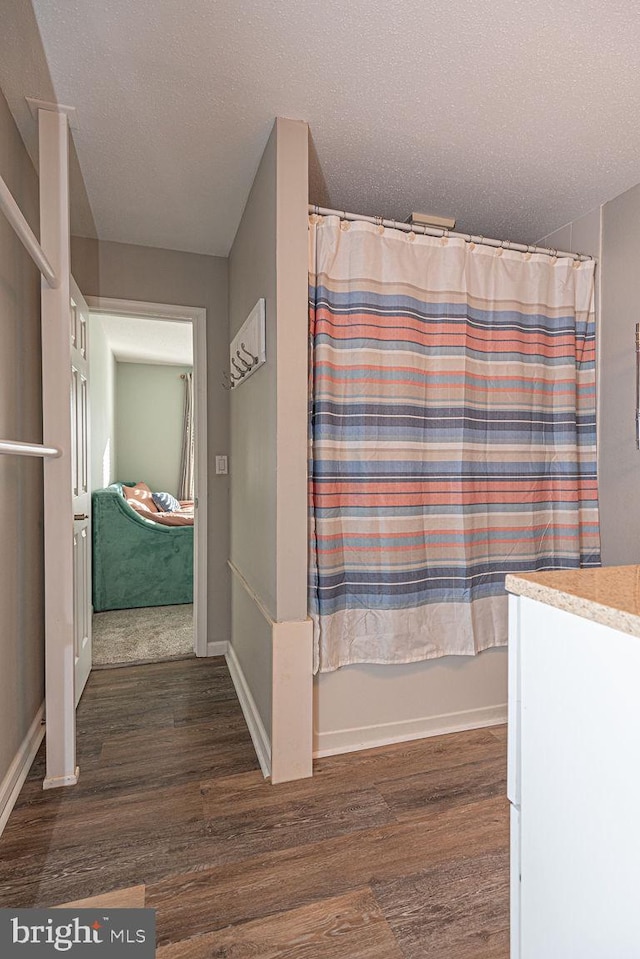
[91,483,193,612]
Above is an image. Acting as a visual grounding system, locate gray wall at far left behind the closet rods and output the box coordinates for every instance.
[0,84,44,783]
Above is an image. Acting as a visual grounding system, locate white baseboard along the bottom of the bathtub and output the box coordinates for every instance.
[313,703,507,759]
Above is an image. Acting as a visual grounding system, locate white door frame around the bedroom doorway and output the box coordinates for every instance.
[85,296,209,656]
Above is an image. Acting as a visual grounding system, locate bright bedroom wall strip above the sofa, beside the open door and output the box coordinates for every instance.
[89,313,118,490]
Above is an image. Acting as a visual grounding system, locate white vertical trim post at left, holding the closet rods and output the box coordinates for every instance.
[38,110,78,789]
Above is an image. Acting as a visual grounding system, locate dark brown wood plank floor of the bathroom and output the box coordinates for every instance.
[0,659,509,959]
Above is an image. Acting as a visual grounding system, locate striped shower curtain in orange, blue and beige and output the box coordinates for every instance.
[309,215,600,671]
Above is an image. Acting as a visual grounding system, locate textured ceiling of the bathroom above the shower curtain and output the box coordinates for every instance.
[0,0,640,255]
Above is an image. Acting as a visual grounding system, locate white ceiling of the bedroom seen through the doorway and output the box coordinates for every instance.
[99,313,193,366]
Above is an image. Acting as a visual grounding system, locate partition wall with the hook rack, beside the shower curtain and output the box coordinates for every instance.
[229,119,312,752]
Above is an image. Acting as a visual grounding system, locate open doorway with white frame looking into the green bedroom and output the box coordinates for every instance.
[87,297,209,667]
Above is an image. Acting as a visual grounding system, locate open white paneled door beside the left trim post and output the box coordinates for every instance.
[69,278,92,706]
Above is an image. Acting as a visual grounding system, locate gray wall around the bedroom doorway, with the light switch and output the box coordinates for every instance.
[71,237,230,642]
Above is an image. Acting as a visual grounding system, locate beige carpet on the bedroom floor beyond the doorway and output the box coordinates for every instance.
[93,603,194,666]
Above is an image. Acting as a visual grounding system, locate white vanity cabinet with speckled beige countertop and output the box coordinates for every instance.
[507,567,640,959]
